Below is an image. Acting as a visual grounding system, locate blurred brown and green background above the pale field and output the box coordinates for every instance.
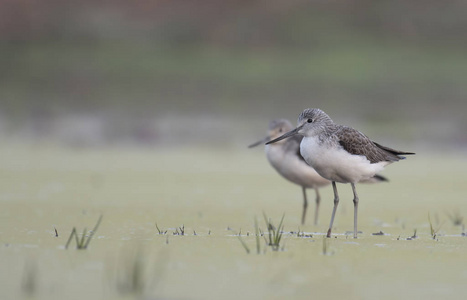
[0,0,467,151]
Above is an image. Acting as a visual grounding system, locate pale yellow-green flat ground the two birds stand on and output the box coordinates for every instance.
[0,144,467,299]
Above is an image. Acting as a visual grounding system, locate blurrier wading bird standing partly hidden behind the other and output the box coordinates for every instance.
[248,119,331,225]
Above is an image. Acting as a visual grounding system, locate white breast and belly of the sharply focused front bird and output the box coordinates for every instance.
[300,137,389,183]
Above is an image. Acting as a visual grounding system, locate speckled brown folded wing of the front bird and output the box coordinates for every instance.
[335,126,409,164]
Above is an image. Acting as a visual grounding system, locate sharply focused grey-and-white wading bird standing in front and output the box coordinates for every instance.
[266,108,415,238]
